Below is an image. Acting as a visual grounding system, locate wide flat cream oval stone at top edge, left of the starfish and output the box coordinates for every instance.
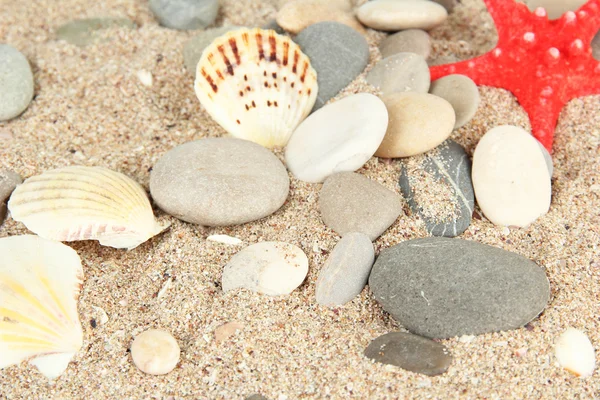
[356,0,448,31]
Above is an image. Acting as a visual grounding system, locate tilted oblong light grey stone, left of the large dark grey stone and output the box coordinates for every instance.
[315,232,375,306]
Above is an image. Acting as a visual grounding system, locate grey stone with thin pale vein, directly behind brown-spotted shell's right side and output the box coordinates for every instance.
[294,21,369,111]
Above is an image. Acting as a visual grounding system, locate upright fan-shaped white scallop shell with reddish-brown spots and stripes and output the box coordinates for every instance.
[194,29,318,148]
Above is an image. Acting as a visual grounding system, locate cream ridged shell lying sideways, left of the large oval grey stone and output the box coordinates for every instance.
[8,167,168,249]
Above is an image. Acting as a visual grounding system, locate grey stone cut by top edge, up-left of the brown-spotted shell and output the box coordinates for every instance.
[148,0,219,30]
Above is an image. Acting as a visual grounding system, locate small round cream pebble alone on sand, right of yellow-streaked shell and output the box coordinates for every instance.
[131,329,180,375]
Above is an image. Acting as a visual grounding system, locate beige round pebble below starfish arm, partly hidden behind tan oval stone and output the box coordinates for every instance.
[429,74,479,129]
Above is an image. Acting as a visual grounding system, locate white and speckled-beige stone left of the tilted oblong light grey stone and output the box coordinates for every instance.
[222,242,308,296]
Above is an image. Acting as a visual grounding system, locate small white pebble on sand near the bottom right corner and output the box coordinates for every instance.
[555,328,596,378]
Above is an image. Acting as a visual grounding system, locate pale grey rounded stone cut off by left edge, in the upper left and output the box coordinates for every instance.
[0,44,33,121]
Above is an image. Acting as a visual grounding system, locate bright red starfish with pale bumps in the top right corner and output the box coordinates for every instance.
[431,0,600,151]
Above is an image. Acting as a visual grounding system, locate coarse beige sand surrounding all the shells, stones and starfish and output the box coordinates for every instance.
[0,0,600,399]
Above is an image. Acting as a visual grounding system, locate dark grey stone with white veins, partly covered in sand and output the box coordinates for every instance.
[400,140,475,237]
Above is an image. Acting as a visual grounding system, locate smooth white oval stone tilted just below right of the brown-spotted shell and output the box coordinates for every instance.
[285,93,388,182]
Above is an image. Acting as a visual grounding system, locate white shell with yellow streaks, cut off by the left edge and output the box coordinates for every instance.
[0,235,83,379]
